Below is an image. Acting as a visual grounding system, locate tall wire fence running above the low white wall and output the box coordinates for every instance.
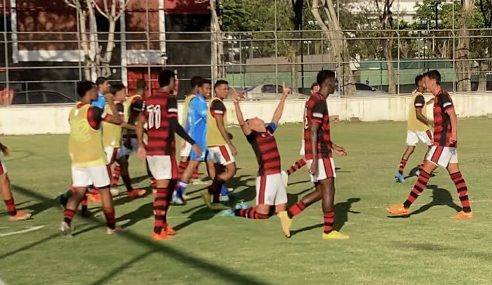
[0,0,492,103]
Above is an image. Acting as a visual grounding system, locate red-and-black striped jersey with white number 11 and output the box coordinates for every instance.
[142,91,178,155]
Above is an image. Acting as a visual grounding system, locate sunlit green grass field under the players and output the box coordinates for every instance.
[0,119,492,285]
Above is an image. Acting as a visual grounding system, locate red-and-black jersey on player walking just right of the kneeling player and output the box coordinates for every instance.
[304,93,332,159]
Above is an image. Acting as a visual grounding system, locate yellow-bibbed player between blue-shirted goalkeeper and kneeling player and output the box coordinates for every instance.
[203,80,237,204]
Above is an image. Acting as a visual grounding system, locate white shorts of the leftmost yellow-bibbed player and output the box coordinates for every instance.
[72,165,110,188]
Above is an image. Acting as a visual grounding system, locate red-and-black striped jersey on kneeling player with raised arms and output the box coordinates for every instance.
[246,123,282,176]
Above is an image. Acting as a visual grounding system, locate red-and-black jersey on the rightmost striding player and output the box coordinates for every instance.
[434,90,456,147]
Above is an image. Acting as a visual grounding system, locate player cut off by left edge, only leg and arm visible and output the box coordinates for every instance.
[0,143,31,222]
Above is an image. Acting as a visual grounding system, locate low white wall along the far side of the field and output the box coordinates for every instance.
[0,93,492,135]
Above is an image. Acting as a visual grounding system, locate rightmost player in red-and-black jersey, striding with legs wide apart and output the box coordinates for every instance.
[386,70,473,220]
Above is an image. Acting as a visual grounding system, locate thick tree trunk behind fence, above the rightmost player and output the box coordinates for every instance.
[455,0,474,92]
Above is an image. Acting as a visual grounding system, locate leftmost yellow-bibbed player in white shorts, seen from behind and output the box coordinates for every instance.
[60,81,122,235]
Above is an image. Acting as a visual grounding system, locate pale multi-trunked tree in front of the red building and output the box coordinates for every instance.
[65,0,132,81]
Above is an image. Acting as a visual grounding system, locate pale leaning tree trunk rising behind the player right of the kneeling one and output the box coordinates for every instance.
[311,0,355,96]
